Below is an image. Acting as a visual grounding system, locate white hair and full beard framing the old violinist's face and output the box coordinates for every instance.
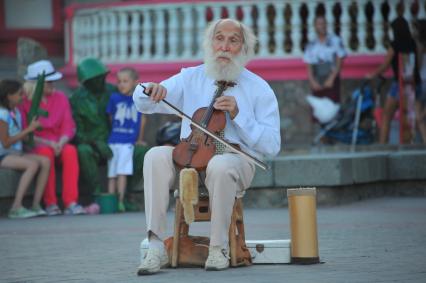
[203,19,257,80]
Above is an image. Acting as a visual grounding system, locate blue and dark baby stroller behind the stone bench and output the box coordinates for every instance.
[313,81,375,149]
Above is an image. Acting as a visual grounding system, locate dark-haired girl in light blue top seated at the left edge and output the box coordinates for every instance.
[0,80,50,218]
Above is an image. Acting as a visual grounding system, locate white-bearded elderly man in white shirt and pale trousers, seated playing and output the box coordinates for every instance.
[133,19,281,275]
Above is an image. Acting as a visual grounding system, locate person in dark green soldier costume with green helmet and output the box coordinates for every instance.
[70,58,149,204]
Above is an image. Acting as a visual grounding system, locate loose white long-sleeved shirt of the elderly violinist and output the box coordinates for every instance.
[133,65,281,161]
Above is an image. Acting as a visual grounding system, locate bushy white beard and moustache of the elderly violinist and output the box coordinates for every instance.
[204,49,248,81]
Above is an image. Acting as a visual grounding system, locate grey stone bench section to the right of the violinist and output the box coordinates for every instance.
[240,150,426,207]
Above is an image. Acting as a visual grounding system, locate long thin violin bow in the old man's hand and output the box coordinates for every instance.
[139,84,269,170]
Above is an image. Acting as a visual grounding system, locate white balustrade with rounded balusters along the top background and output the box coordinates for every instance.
[65,0,426,64]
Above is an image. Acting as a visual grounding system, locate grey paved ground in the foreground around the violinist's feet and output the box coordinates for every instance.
[0,198,426,283]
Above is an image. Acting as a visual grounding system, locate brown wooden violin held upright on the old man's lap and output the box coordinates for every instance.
[173,81,235,171]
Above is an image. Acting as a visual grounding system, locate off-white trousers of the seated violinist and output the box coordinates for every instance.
[143,146,255,246]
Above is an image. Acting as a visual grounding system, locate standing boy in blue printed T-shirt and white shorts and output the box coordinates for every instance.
[106,68,146,212]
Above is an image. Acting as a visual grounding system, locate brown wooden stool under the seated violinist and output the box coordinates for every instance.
[171,189,251,267]
